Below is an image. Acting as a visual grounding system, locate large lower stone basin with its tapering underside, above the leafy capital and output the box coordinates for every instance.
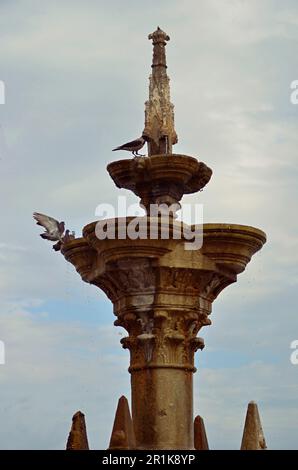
[62,217,266,324]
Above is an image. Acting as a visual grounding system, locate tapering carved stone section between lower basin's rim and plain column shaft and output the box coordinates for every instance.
[93,264,232,370]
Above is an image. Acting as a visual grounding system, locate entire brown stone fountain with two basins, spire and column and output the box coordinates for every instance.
[61,28,266,449]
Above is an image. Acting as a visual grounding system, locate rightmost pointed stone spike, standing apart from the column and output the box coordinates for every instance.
[241,401,267,450]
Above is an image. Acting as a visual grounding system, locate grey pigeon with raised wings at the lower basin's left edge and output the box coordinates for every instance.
[33,212,75,251]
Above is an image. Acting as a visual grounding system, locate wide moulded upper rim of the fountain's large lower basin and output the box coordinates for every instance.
[62,217,266,283]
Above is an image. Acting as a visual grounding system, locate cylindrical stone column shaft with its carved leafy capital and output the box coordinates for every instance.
[116,306,208,449]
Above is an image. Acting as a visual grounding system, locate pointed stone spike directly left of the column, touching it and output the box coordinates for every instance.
[109,396,136,450]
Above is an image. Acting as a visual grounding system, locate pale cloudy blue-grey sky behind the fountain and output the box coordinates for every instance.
[0,0,298,449]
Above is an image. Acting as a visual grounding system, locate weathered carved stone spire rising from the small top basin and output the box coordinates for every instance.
[143,27,178,156]
